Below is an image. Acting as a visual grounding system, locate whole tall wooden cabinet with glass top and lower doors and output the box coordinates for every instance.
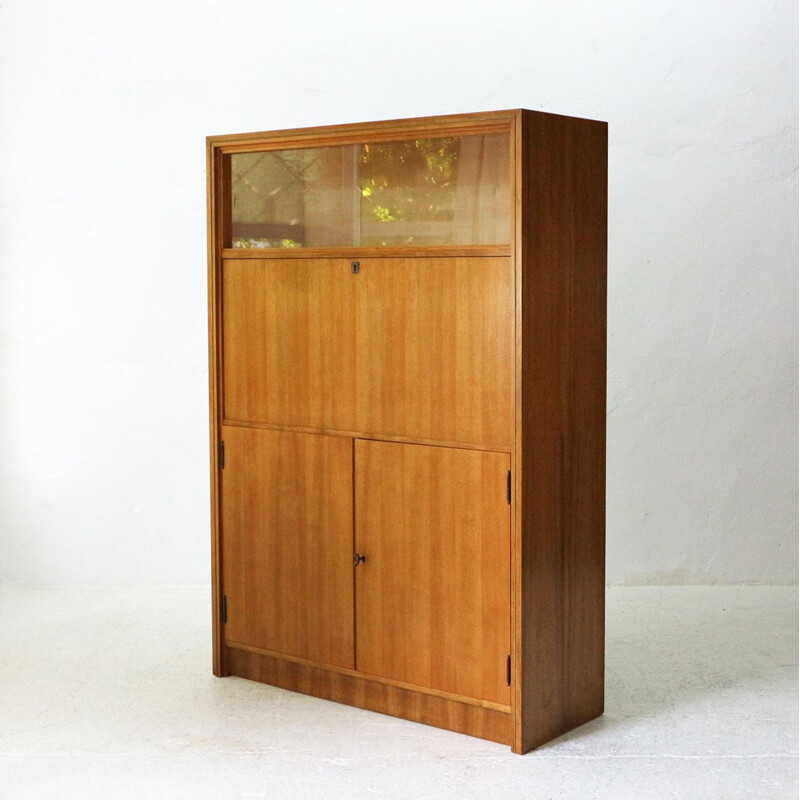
[208,110,607,753]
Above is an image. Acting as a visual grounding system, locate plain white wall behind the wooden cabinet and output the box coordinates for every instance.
[0,0,798,583]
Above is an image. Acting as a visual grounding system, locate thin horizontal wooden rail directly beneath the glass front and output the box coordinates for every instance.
[222,244,512,261]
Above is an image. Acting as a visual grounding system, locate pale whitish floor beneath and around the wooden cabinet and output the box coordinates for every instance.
[0,586,798,800]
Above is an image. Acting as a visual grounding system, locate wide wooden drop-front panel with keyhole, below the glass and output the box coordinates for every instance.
[223,258,514,446]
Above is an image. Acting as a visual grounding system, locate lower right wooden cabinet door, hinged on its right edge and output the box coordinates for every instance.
[355,439,511,705]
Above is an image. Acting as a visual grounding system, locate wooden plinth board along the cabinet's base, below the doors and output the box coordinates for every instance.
[228,650,511,744]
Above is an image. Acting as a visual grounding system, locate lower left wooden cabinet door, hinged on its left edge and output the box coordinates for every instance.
[221,425,354,668]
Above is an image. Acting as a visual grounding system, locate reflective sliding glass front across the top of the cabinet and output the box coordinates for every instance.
[231,133,511,248]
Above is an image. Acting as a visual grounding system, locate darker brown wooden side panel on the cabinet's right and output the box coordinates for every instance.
[514,111,607,752]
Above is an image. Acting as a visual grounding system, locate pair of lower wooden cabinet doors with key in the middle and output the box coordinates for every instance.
[222,426,511,705]
